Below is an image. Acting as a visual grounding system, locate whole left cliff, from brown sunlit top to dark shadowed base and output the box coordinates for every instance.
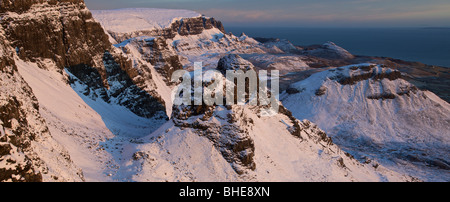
[0,0,168,117]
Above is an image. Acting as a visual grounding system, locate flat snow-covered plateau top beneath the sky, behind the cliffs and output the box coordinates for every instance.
[91,8,201,33]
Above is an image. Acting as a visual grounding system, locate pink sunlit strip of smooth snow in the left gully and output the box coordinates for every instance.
[17,60,114,181]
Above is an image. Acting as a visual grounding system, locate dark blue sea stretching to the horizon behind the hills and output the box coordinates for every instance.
[226,27,450,67]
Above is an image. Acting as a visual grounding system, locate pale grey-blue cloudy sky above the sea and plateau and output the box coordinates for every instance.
[85,0,450,27]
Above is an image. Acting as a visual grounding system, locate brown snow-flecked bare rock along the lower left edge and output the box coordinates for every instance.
[0,57,44,182]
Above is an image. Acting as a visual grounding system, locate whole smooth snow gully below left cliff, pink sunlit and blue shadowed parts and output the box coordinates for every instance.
[16,56,169,181]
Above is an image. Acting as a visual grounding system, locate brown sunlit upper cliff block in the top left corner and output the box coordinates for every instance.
[0,0,111,69]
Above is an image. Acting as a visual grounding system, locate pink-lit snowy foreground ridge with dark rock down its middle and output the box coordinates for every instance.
[116,102,413,182]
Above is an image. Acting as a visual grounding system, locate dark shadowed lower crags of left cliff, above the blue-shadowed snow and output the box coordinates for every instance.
[67,52,167,119]
